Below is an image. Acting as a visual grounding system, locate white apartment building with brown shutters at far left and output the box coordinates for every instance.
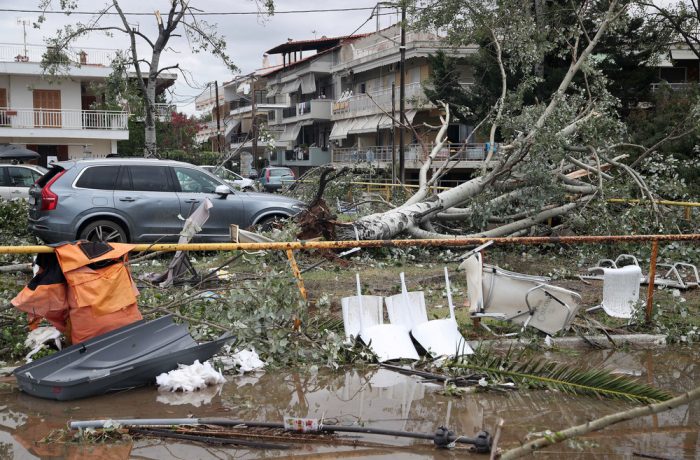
[0,44,176,165]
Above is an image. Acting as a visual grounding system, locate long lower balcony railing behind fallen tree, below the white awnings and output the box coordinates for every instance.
[333,143,499,163]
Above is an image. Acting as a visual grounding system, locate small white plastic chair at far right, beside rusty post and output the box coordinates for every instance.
[586,265,642,319]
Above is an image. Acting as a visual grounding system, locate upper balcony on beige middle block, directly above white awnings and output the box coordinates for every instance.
[332,83,432,120]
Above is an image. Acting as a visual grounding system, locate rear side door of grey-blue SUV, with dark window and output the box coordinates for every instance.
[114,165,184,241]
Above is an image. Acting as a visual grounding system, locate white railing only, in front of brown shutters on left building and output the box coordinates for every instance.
[0,107,129,130]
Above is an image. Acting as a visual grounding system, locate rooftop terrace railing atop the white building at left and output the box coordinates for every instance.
[0,43,117,67]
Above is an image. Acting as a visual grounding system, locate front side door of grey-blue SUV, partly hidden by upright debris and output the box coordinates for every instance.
[172,166,250,241]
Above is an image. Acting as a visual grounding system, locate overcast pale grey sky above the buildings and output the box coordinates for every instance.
[0,0,404,114]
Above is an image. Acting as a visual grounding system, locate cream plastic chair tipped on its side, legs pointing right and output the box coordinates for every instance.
[460,253,581,336]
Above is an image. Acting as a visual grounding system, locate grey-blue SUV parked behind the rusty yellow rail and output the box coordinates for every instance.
[29,158,303,243]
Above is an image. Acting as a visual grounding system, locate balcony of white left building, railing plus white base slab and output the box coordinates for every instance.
[0,107,129,140]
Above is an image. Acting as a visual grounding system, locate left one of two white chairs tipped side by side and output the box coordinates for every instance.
[341,275,418,363]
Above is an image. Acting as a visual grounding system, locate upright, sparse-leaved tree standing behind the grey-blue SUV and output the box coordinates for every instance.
[38,0,241,157]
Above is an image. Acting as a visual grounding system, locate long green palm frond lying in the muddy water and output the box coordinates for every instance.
[449,353,673,404]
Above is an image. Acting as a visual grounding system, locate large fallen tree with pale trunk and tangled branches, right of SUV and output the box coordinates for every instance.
[324,0,700,239]
